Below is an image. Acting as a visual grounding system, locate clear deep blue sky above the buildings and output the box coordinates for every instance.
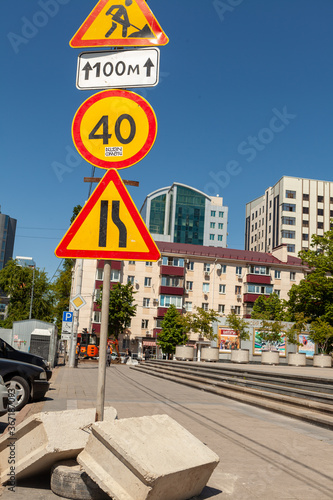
[0,0,333,278]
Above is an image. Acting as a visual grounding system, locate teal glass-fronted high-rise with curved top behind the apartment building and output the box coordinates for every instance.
[141,182,228,248]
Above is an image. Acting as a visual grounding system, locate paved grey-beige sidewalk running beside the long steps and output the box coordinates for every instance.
[0,363,333,500]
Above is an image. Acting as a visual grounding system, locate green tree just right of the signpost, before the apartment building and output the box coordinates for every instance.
[97,283,137,340]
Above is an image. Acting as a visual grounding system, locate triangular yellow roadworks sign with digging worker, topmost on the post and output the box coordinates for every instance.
[69,0,169,48]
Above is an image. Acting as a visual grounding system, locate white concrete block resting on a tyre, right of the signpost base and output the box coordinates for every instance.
[77,415,219,500]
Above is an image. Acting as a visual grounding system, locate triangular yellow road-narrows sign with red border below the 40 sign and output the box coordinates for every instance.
[55,169,161,262]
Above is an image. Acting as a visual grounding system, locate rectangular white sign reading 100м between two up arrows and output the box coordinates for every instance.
[76,47,160,90]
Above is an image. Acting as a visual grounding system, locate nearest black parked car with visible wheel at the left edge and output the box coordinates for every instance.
[0,359,50,411]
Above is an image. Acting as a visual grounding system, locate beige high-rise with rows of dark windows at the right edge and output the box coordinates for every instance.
[245,176,333,256]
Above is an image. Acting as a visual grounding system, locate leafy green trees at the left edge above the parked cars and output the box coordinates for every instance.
[0,260,54,328]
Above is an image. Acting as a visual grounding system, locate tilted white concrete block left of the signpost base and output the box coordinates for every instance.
[0,408,117,484]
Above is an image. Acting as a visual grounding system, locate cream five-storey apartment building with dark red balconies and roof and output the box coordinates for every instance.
[73,242,305,354]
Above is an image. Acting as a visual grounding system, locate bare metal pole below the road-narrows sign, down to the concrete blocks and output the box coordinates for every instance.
[95,260,111,422]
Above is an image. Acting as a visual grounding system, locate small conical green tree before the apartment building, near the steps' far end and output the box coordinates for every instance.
[157,304,188,355]
